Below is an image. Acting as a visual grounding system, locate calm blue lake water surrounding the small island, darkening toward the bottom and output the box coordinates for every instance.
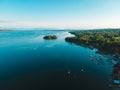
[0,30,112,90]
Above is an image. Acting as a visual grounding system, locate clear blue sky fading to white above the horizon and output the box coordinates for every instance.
[0,0,120,29]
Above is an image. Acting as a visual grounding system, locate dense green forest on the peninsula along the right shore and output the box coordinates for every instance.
[65,29,120,54]
